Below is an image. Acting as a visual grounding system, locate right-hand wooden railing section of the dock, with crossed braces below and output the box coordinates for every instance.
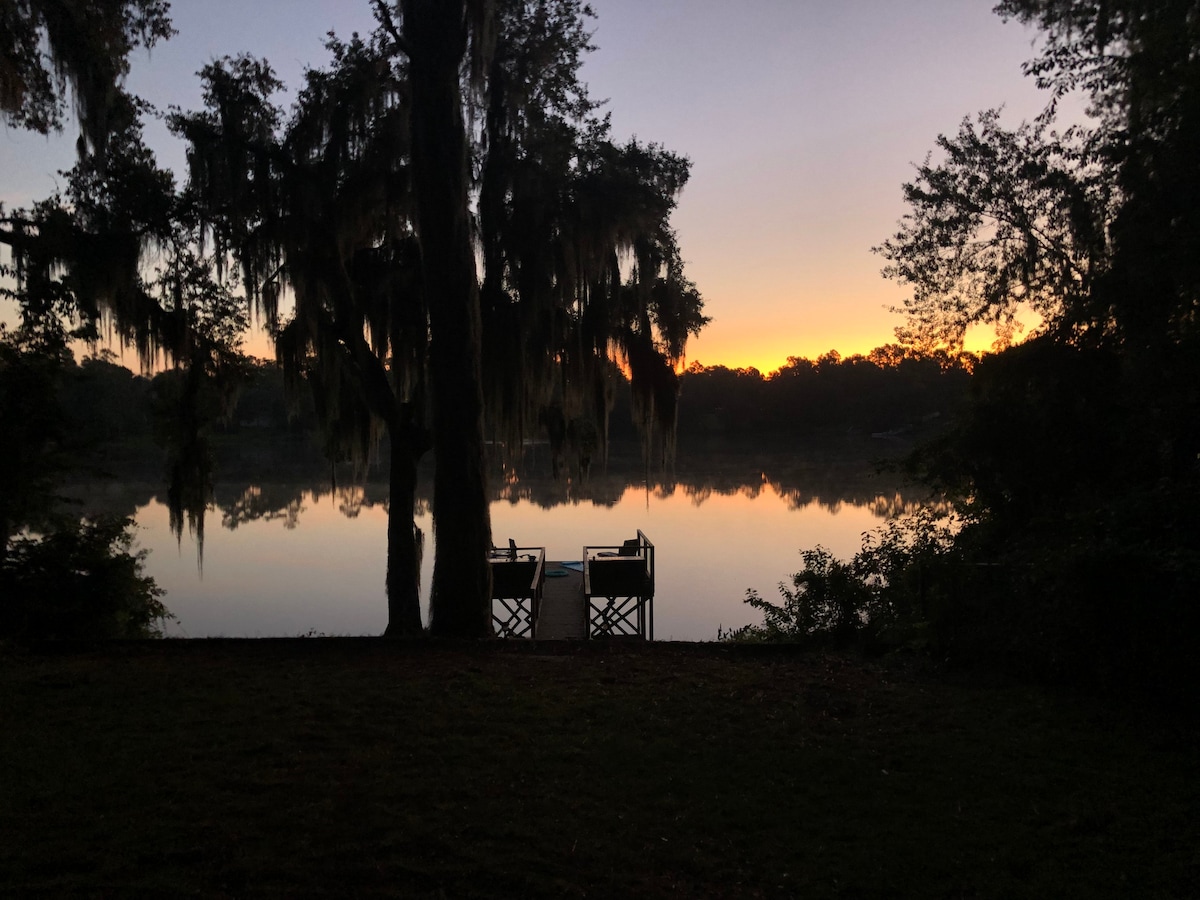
[583,529,654,641]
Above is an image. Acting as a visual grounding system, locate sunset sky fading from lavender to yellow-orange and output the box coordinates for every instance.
[0,0,1046,372]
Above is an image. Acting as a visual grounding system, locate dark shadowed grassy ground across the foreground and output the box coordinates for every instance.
[0,638,1200,898]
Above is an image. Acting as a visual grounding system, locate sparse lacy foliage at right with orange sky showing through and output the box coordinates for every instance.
[876,109,1115,348]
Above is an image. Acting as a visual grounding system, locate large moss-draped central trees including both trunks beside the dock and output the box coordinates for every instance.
[174,0,702,635]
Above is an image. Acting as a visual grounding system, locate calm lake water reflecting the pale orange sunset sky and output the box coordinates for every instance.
[75,444,936,641]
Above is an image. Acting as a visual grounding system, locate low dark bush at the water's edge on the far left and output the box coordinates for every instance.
[0,517,173,640]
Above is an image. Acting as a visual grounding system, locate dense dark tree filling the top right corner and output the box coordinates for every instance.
[998,0,1200,353]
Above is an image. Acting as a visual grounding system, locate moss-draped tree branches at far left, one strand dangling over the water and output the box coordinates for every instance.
[0,0,245,578]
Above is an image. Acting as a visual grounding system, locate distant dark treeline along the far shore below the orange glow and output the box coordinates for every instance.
[61,347,977,472]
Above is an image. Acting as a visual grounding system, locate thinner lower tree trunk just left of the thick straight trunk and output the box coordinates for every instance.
[384,434,422,637]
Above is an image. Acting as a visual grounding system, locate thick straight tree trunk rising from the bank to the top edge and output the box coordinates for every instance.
[404,0,492,637]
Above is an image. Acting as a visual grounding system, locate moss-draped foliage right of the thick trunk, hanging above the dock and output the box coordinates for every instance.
[479,0,707,464]
